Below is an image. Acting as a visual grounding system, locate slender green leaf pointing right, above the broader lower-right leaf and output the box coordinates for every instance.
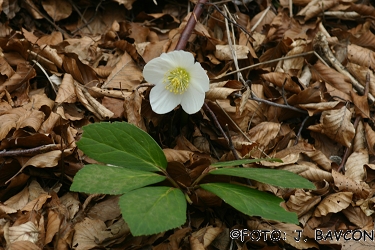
[210,168,315,189]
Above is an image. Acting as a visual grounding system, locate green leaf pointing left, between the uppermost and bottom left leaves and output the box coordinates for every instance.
[70,164,166,194]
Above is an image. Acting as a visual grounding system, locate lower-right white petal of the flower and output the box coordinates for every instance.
[181,86,205,115]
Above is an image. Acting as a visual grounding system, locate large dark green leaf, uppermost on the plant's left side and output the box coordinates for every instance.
[77,122,167,172]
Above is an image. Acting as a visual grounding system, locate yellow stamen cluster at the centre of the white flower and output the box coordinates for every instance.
[164,67,190,94]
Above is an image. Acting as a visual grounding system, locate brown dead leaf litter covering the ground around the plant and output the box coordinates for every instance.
[0,0,375,249]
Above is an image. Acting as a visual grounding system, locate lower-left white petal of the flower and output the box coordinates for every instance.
[150,84,182,114]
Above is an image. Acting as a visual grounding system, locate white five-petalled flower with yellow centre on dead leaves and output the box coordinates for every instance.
[143,50,209,114]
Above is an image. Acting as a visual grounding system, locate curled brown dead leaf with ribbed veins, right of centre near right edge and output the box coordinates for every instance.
[308,106,355,147]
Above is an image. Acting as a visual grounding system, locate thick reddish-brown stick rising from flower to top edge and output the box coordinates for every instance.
[175,0,207,50]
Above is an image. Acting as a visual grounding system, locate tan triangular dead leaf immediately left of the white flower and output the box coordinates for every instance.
[102,52,143,91]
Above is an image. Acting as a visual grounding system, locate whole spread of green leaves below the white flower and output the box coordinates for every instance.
[70,122,315,236]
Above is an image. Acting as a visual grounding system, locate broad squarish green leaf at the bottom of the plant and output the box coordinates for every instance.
[119,187,186,236]
